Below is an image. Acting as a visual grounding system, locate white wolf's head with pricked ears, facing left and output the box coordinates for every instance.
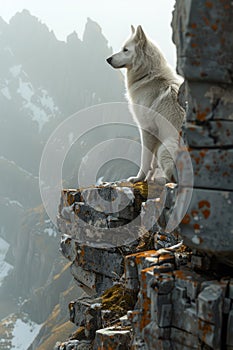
[107,26,147,69]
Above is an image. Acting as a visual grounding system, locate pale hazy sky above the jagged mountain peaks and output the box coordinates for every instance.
[0,0,176,66]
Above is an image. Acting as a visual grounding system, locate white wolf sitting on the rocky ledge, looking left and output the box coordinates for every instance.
[107,26,184,182]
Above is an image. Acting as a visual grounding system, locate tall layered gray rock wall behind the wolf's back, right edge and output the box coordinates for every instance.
[172,0,233,264]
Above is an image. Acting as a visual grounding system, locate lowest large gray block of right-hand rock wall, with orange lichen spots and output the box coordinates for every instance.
[181,189,233,261]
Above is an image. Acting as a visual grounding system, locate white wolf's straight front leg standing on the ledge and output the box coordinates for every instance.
[128,130,159,183]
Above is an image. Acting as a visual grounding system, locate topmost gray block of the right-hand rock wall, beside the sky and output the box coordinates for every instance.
[172,0,233,83]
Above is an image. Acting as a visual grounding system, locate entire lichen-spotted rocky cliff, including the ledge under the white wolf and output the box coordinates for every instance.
[54,0,233,350]
